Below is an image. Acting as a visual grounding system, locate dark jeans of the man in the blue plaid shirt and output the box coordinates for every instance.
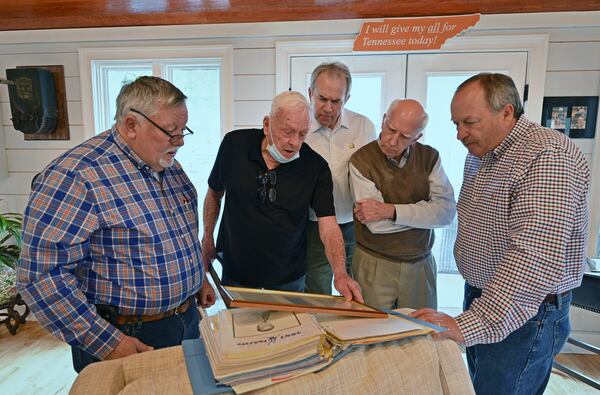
[71,298,200,373]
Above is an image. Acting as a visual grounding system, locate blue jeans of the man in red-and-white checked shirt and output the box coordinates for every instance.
[464,283,571,395]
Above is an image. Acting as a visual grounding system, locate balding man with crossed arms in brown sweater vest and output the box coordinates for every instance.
[350,100,456,309]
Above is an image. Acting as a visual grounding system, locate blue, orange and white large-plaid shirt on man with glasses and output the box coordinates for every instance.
[18,128,203,358]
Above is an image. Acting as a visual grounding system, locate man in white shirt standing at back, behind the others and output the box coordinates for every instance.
[305,62,376,294]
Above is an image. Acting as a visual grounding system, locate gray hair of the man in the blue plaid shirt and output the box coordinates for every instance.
[115,76,187,123]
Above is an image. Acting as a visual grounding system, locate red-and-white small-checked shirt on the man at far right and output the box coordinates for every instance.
[454,116,590,346]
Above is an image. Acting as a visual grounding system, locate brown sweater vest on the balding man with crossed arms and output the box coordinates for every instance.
[350,141,439,261]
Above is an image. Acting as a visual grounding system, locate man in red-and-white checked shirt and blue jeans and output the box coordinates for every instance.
[413,73,590,394]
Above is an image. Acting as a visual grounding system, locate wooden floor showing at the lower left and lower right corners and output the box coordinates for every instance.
[0,321,600,395]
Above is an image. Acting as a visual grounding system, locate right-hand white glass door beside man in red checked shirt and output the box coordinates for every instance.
[406,52,527,314]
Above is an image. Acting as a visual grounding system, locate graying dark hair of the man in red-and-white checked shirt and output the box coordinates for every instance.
[454,73,524,119]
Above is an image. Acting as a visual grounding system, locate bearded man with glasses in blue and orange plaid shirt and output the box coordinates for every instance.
[17,77,214,372]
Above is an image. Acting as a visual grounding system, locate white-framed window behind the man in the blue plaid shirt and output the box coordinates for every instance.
[79,47,232,217]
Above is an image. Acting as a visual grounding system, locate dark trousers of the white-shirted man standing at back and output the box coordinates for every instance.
[305,221,356,295]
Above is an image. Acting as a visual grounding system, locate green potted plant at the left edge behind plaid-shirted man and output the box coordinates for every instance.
[0,213,29,335]
